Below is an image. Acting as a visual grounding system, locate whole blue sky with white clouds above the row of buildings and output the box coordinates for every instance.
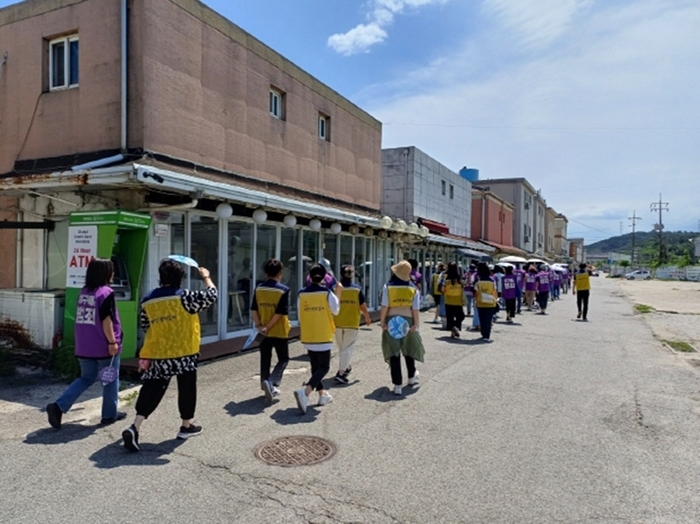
[0,0,700,243]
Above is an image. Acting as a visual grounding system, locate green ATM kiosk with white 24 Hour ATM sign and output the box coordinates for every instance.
[63,211,151,359]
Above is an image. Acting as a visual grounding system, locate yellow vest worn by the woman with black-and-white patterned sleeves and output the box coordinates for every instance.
[140,296,201,360]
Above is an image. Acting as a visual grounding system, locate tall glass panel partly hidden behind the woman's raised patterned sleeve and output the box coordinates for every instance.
[189,216,219,337]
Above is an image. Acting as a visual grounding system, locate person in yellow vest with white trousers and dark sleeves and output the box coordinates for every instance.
[333,264,372,384]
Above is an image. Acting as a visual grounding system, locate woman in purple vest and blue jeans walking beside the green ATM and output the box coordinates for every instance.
[46,258,126,429]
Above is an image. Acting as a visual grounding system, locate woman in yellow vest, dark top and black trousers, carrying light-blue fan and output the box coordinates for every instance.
[250,258,290,402]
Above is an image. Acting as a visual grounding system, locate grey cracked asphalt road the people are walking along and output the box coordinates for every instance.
[0,278,700,523]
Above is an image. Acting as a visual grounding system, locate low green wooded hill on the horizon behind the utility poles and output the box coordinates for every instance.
[586,231,700,265]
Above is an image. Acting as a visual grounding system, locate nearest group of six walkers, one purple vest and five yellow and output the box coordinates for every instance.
[46,254,424,452]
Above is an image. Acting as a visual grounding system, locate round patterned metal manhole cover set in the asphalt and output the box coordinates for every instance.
[255,436,336,466]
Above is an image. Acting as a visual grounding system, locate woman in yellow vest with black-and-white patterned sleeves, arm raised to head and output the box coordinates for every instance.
[122,258,217,451]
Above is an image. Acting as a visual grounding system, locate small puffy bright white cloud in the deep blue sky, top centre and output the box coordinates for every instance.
[328,0,449,56]
